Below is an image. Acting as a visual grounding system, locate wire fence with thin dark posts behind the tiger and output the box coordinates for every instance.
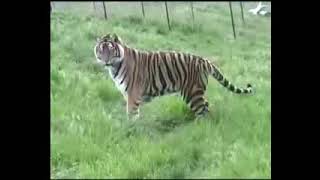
[51,1,271,38]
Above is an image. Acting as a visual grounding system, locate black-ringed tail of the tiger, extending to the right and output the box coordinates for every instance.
[209,63,253,94]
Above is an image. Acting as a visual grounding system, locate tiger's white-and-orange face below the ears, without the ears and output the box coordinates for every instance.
[94,40,121,66]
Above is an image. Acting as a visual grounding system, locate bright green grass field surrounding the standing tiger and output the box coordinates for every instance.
[51,1,271,178]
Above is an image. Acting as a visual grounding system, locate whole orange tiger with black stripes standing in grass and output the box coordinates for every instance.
[94,33,253,119]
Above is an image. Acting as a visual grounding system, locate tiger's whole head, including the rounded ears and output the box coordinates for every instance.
[94,34,124,66]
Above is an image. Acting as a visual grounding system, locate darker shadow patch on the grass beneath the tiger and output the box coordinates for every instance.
[102,102,221,144]
